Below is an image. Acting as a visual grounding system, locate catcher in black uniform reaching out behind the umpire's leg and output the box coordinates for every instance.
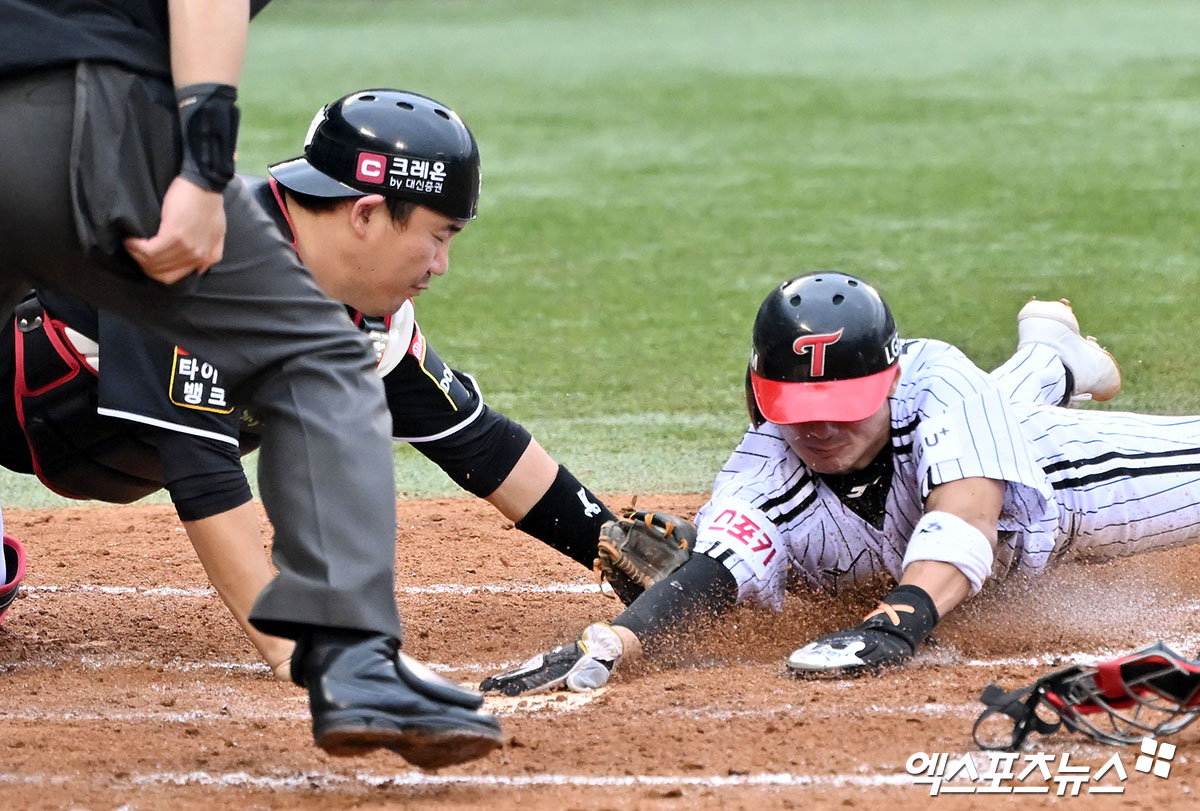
[0,86,628,679]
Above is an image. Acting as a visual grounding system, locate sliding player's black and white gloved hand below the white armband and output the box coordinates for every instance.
[787,585,938,677]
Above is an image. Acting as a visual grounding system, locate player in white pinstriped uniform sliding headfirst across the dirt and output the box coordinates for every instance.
[482,271,1200,692]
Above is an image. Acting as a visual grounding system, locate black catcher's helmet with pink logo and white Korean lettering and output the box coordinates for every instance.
[268,89,480,220]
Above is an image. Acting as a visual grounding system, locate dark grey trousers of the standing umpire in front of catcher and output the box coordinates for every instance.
[0,64,400,638]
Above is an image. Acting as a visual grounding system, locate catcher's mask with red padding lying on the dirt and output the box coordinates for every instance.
[973,642,1200,750]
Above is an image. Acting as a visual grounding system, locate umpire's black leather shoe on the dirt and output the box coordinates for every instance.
[292,631,502,769]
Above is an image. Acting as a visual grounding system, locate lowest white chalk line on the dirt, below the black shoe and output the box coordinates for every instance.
[0,771,912,792]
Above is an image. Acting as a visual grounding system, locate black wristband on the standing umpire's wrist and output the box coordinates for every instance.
[175,82,241,192]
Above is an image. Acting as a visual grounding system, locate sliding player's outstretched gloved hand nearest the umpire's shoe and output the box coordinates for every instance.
[479,623,624,696]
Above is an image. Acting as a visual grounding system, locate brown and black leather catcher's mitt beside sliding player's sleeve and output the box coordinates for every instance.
[594,507,696,606]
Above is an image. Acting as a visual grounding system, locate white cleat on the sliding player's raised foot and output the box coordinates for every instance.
[1016,299,1121,401]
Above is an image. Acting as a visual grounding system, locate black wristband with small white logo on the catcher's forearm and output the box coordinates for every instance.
[516,465,617,569]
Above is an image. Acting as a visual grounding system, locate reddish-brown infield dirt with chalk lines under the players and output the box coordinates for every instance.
[0,494,1200,811]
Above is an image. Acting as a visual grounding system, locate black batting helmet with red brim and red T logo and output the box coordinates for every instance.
[748,271,900,425]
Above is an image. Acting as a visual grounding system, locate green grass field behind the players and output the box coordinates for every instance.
[9,0,1200,504]
